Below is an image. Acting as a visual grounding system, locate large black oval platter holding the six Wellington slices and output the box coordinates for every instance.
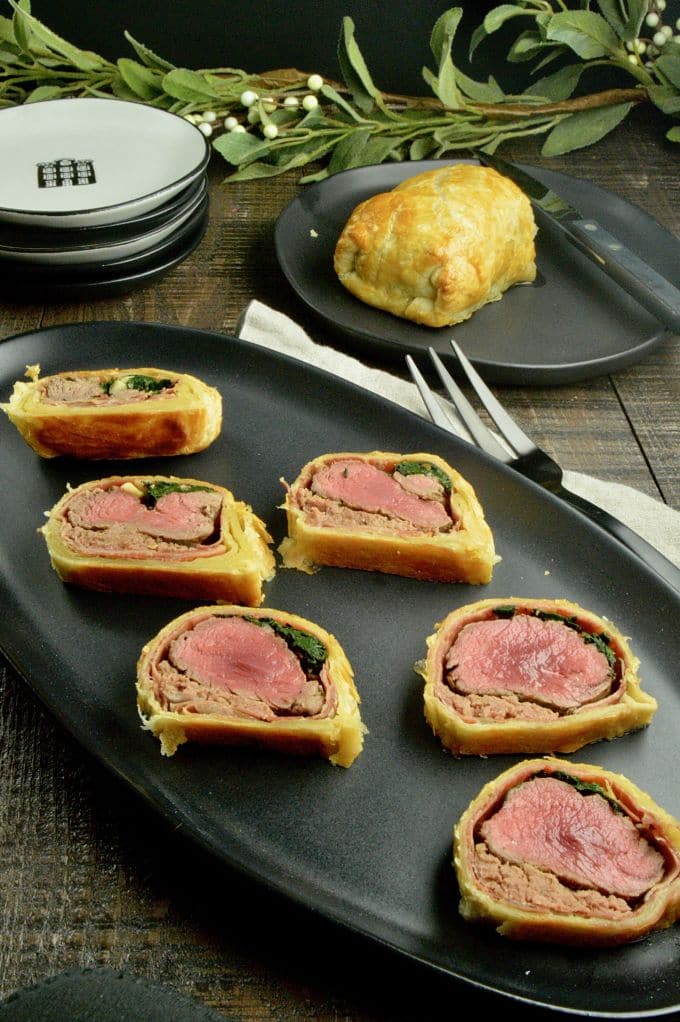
[0,322,680,1018]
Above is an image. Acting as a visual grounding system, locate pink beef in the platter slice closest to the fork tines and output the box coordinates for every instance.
[311,459,452,531]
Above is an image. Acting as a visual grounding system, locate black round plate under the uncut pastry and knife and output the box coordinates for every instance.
[275,160,680,385]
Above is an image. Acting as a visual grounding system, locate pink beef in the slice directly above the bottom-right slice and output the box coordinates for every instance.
[445,614,613,710]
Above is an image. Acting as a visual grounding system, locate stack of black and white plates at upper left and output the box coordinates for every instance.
[0,98,210,300]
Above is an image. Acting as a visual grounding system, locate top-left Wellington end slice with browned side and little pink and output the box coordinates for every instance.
[1,365,222,460]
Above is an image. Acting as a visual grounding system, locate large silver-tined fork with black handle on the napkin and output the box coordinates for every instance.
[406,340,680,592]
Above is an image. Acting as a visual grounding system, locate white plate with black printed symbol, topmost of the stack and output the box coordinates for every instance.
[0,98,211,228]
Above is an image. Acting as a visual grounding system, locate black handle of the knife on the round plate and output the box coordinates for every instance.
[560,220,680,333]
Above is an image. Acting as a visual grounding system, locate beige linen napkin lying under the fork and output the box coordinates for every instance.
[238,301,680,567]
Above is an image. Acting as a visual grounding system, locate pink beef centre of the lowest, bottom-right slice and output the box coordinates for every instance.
[480,777,664,898]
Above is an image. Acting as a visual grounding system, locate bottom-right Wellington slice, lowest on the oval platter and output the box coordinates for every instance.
[453,757,680,946]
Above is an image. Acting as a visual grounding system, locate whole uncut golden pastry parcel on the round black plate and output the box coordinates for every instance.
[333,164,536,327]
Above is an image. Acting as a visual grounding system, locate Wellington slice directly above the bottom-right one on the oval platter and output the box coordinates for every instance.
[415,597,658,756]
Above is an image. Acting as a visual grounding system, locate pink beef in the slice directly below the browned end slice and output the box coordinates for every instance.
[67,486,222,543]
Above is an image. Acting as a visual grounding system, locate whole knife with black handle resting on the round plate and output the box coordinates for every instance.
[474,150,680,333]
